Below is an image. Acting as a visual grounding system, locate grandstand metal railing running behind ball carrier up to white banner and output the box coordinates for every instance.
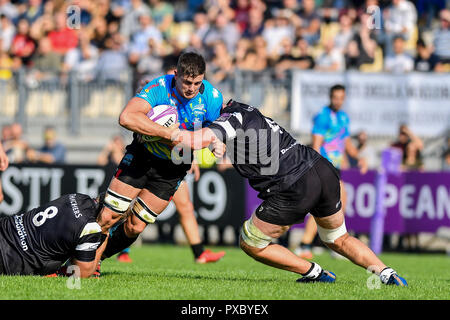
[0,69,291,135]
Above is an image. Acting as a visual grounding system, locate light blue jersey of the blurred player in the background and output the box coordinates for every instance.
[312,107,350,169]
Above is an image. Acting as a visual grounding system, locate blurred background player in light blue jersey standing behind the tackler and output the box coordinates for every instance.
[295,84,367,259]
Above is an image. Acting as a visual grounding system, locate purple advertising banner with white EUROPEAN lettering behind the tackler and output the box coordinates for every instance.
[246,170,450,233]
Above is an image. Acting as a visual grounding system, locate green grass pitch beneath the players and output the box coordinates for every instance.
[0,244,450,300]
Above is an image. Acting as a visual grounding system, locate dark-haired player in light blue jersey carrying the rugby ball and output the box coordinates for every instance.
[93,52,223,268]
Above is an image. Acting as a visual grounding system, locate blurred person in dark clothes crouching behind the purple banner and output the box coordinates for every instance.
[392,124,423,171]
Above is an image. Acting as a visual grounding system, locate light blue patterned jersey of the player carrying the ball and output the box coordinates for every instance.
[136,75,223,159]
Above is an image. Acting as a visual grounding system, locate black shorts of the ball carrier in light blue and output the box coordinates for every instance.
[115,141,191,201]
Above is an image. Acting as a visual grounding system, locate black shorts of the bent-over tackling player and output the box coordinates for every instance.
[256,157,342,226]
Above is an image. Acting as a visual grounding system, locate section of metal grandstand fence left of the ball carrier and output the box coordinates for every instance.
[0,69,133,135]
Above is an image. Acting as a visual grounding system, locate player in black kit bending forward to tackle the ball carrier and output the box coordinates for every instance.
[172,101,407,286]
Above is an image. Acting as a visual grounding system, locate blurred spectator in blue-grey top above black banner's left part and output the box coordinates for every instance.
[27,126,66,164]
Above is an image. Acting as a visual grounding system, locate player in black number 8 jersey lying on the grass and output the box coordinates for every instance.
[0,193,105,278]
